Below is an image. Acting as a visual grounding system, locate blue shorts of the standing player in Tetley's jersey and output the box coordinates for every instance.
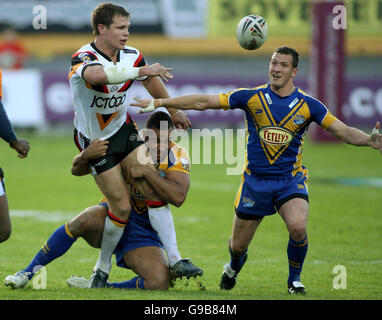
[235,168,309,220]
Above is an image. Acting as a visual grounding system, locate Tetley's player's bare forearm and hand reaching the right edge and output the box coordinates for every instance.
[328,120,382,150]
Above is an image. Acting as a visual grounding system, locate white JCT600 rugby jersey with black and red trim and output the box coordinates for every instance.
[69,42,147,141]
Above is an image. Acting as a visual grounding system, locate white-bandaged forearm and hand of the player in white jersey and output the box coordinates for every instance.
[83,63,173,85]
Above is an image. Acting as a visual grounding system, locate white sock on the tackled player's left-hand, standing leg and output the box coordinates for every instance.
[95,216,124,273]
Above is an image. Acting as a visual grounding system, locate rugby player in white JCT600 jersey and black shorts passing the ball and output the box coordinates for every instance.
[69,3,190,287]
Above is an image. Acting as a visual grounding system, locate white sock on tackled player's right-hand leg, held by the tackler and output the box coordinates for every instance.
[148,205,182,267]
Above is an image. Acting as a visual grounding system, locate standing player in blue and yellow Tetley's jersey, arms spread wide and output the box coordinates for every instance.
[131,47,382,294]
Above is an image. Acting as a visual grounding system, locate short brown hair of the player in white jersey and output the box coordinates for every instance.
[91,2,130,35]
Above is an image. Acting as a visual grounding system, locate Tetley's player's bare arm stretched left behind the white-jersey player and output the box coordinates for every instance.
[130,94,223,113]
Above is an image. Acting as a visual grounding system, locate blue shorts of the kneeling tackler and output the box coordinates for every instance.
[99,202,163,269]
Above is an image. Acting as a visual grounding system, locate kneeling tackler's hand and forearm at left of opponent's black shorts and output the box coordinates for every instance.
[71,139,109,176]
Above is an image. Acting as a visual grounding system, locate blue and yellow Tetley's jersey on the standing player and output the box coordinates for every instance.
[219,84,337,178]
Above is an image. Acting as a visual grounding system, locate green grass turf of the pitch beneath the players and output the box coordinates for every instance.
[0,133,382,300]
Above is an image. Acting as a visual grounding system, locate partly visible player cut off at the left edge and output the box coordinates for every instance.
[0,69,29,242]
